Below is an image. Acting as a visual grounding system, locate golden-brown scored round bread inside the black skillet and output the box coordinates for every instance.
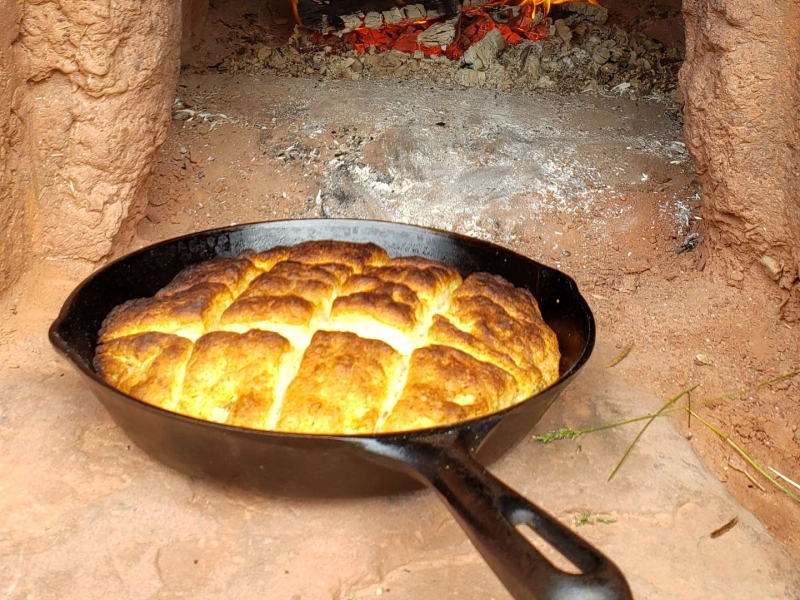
[95,240,560,435]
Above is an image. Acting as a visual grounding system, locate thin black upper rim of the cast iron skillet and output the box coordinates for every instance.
[48,219,596,442]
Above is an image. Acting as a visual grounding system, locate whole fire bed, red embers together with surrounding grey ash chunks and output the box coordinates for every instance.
[255,0,683,99]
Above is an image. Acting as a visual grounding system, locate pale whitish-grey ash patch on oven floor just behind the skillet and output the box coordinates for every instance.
[310,86,672,241]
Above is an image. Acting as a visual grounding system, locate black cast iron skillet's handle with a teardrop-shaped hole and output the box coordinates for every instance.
[372,442,632,600]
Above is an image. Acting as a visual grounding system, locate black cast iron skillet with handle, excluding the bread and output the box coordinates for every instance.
[50,220,631,600]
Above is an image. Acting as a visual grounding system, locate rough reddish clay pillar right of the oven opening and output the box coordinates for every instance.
[681,0,800,320]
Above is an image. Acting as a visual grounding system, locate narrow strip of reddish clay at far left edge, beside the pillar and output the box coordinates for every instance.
[0,0,27,292]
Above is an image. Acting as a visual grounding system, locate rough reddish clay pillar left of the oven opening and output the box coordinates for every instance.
[9,0,181,260]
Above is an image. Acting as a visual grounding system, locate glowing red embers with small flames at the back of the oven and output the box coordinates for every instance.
[292,0,599,60]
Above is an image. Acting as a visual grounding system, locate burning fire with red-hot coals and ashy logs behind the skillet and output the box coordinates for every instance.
[292,0,603,60]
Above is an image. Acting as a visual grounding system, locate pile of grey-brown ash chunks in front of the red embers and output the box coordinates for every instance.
[216,3,684,104]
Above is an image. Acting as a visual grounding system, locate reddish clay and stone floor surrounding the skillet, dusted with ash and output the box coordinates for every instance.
[0,74,800,600]
